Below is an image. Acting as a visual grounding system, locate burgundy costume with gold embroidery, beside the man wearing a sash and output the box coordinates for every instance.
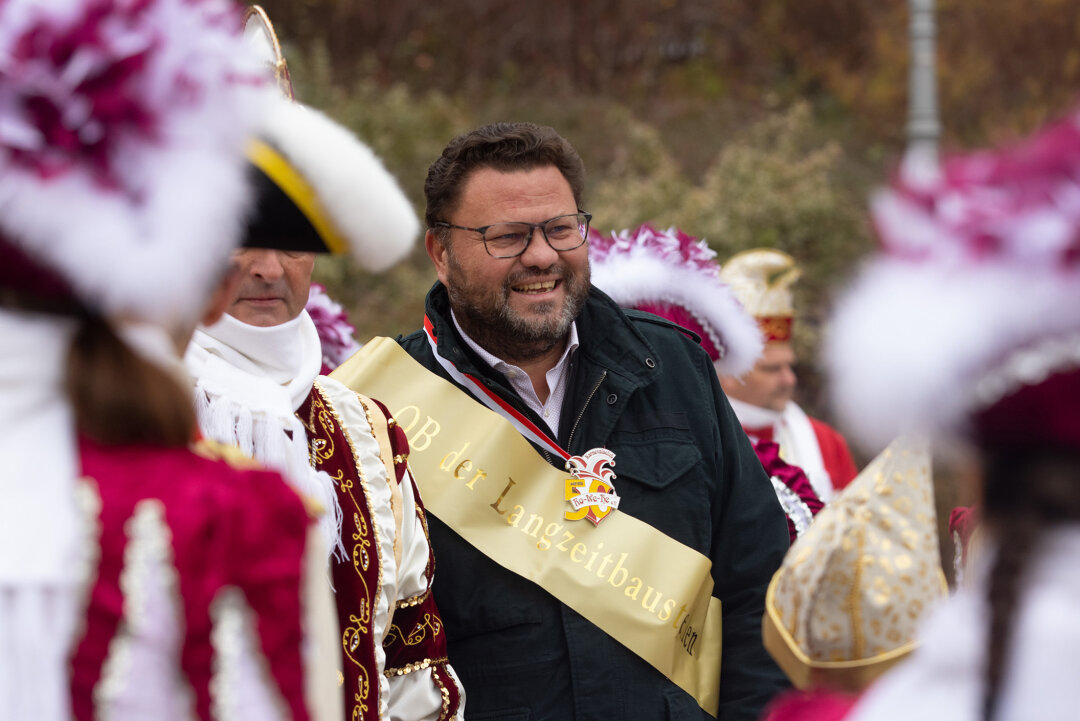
[296,379,462,721]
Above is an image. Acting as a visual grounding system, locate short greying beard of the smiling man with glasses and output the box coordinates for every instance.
[447,274,589,362]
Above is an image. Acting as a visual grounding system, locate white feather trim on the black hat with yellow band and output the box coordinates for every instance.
[259,99,420,272]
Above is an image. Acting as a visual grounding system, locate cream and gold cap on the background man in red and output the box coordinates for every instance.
[720,248,801,342]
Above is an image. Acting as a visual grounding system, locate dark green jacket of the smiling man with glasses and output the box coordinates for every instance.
[399,283,788,721]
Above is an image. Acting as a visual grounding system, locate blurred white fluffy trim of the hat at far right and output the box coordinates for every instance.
[824,258,1080,448]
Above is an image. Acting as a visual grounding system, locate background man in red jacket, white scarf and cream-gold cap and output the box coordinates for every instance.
[720,248,856,503]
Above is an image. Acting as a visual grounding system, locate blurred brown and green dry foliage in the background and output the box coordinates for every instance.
[262,0,1080,433]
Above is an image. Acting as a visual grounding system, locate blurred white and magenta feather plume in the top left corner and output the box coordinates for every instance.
[0,0,271,323]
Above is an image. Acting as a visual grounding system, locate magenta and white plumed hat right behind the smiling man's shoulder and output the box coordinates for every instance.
[589,225,761,376]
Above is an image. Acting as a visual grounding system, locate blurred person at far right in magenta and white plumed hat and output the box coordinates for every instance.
[827,104,1080,721]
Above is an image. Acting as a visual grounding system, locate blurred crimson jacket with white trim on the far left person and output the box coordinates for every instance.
[71,439,309,719]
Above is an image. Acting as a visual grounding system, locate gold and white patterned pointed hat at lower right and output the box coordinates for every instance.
[762,437,948,691]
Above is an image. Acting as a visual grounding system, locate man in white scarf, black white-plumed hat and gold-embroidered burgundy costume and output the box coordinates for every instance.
[185,8,464,720]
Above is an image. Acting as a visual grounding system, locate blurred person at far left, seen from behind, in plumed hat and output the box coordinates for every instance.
[0,0,334,721]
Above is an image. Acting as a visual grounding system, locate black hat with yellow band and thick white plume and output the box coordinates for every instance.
[243,6,420,272]
